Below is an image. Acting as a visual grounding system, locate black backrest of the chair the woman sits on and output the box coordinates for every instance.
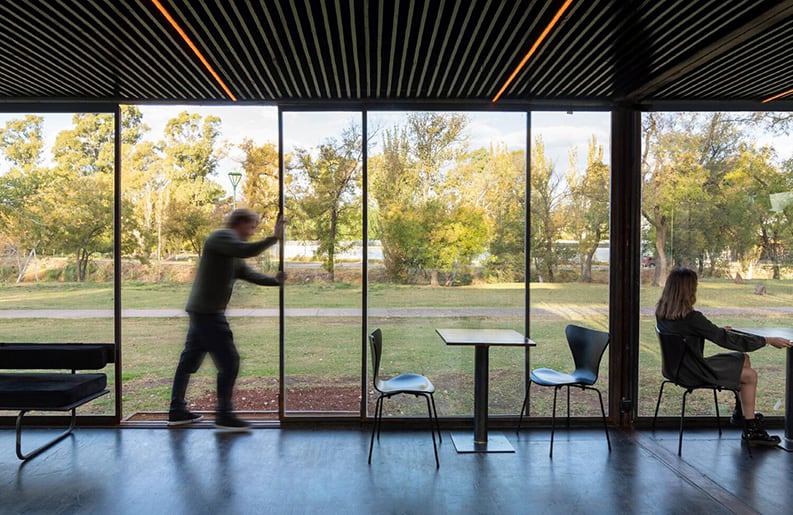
[655,327,718,388]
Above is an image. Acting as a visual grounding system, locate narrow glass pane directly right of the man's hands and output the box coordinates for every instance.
[282,112,364,416]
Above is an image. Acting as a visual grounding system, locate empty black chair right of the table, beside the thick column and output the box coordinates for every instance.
[518,325,611,458]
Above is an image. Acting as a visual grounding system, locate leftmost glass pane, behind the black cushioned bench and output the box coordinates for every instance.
[0,112,115,415]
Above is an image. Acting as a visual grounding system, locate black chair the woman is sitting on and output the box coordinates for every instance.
[653,327,740,456]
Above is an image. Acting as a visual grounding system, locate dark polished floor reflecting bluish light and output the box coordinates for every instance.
[0,427,793,515]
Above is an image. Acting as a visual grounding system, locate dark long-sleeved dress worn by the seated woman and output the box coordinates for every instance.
[656,311,765,389]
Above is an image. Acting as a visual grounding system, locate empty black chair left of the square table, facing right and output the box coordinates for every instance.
[369,329,443,467]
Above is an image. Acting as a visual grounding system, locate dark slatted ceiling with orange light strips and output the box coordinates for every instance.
[0,0,793,110]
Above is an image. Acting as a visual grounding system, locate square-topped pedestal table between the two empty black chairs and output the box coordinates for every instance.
[435,329,535,452]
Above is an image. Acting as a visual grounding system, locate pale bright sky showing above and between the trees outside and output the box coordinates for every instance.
[0,105,793,194]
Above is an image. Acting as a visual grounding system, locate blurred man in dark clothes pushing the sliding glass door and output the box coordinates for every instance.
[168,209,285,431]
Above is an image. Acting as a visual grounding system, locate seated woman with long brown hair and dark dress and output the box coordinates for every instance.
[655,267,791,445]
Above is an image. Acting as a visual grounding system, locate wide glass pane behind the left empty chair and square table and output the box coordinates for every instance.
[367,112,526,417]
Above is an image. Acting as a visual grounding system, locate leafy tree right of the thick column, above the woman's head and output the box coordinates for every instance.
[642,113,756,285]
